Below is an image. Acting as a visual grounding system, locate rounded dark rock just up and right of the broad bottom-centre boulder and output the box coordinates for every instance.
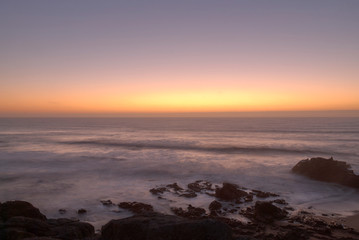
[254,201,287,222]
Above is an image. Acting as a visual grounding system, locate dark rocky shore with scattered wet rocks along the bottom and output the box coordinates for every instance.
[0,159,359,240]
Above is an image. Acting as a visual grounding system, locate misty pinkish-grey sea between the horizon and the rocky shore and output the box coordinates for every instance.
[0,118,359,229]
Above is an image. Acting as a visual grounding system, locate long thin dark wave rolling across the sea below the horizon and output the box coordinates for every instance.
[61,140,355,155]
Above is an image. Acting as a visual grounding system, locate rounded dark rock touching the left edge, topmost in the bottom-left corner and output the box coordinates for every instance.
[0,201,46,221]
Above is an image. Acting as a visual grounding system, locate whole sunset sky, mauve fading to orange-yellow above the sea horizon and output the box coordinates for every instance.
[0,0,359,116]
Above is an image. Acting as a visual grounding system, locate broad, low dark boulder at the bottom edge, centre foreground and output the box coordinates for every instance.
[102,213,232,240]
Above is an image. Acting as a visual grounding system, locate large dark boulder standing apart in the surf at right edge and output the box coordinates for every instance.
[292,157,359,188]
